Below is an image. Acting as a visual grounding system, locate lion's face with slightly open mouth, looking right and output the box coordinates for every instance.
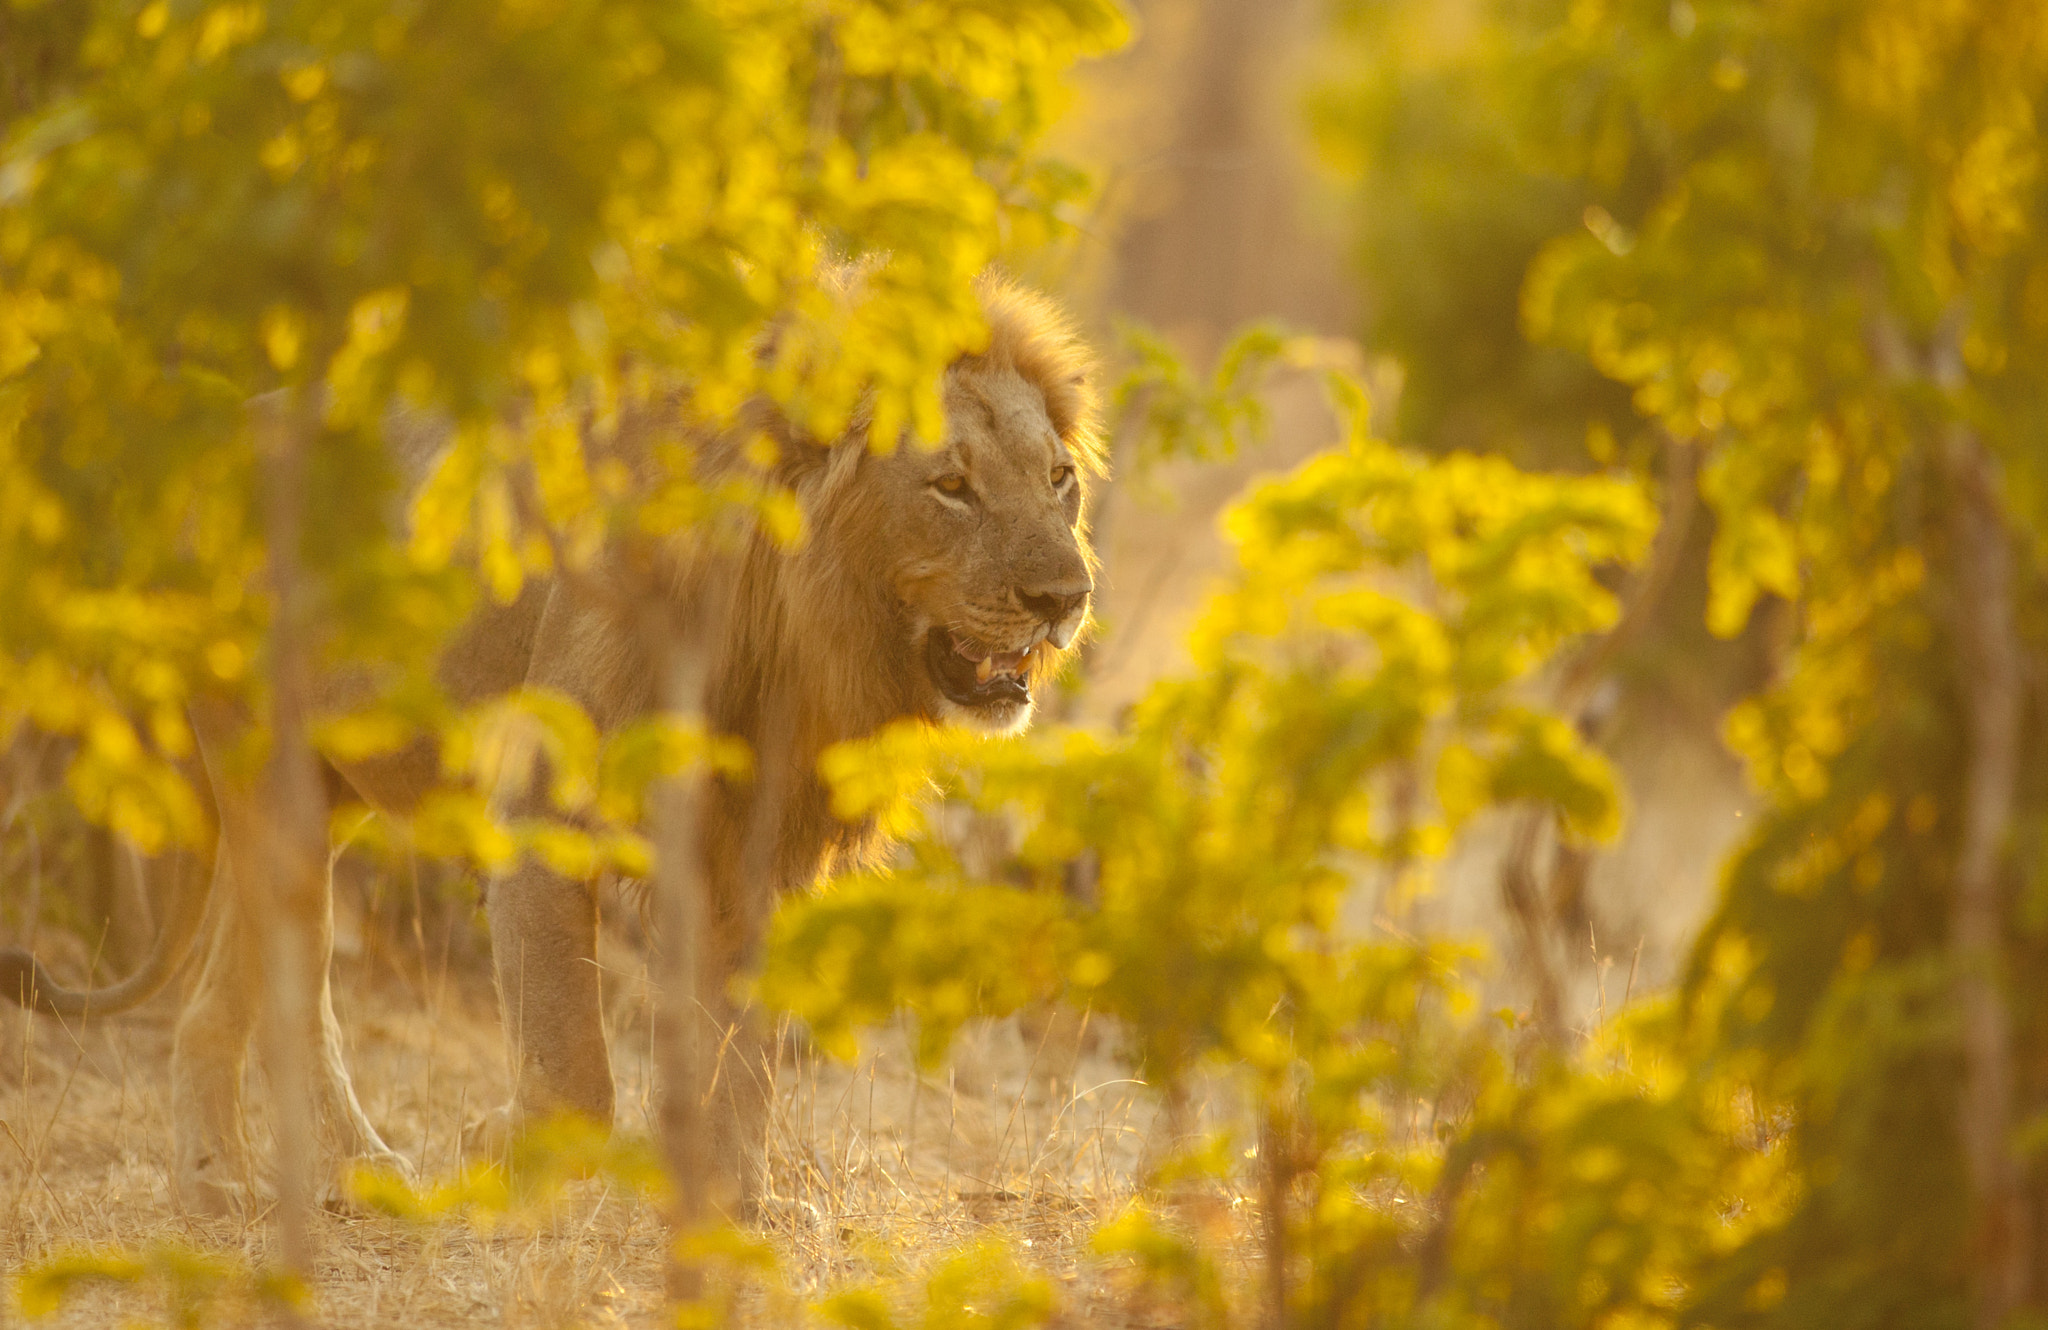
[866,361,1094,732]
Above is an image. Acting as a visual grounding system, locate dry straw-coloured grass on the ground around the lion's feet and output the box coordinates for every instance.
[0,864,1204,1326]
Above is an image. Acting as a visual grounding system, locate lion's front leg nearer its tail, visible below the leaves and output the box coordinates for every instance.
[485,859,612,1133]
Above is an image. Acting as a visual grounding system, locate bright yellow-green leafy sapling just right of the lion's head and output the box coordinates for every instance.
[758,364,1679,1324]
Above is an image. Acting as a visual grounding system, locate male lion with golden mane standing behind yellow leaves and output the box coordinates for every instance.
[0,281,1104,1211]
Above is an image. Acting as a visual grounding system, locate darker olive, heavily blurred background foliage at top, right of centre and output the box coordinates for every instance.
[1309,0,1642,465]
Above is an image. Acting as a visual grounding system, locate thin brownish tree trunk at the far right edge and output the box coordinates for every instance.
[1948,430,2032,1330]
